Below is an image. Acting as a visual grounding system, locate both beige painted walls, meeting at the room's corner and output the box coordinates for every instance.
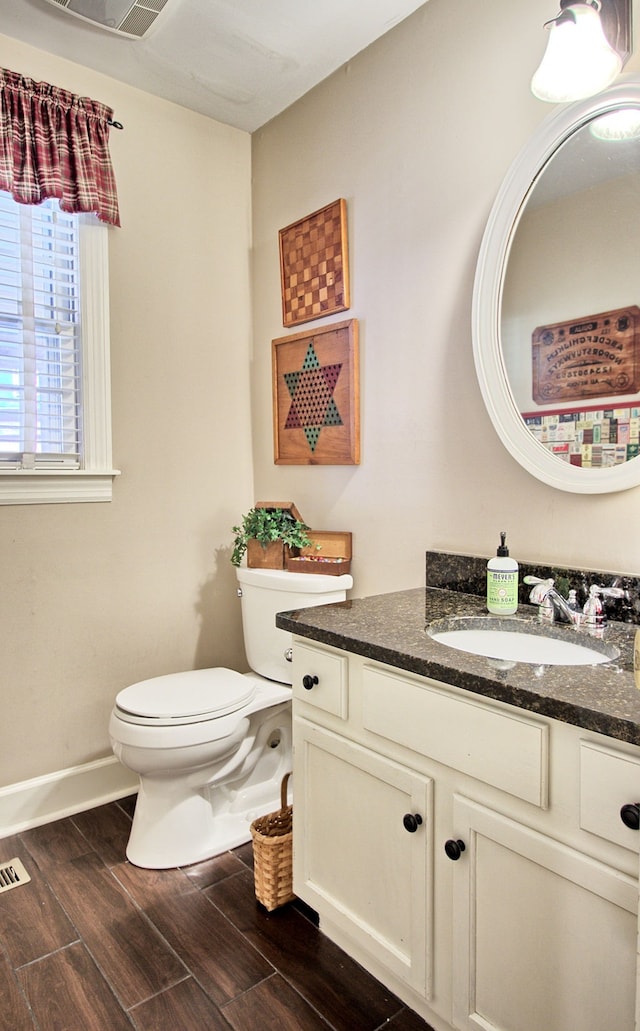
[0,0,640,784]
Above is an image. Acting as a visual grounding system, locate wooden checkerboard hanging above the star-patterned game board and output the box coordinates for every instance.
[279,199,350,326]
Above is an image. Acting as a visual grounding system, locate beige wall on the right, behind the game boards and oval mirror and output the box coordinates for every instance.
[251,0,640,594]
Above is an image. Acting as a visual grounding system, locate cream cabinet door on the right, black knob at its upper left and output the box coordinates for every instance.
[451,796,638,1031]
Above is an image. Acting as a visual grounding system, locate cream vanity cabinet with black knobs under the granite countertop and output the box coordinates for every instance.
[294,638,640,1031]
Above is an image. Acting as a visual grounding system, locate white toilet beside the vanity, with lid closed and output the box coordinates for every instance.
[109,567,353,870]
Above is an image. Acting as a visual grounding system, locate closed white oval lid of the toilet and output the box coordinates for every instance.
[115,667,256,726]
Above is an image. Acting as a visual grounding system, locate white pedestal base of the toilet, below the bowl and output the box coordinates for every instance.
[121,704,292,870]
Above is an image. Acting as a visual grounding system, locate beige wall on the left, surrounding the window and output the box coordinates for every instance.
[0,36,254,785]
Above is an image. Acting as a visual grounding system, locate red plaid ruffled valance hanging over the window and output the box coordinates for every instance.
[0,68,120,226]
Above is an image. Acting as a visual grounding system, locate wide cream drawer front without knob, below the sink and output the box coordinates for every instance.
[363,666,548,808]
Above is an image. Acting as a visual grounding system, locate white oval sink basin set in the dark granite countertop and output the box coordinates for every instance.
[428,617,619,666]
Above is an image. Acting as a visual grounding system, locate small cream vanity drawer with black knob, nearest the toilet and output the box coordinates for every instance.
[293,640,348,720]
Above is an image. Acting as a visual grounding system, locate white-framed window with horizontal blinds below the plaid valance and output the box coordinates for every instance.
[0,192,114,504]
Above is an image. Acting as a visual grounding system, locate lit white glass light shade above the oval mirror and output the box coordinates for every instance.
[531,3,622,103]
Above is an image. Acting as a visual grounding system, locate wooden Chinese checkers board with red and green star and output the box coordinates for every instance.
[271,319,360,465]
